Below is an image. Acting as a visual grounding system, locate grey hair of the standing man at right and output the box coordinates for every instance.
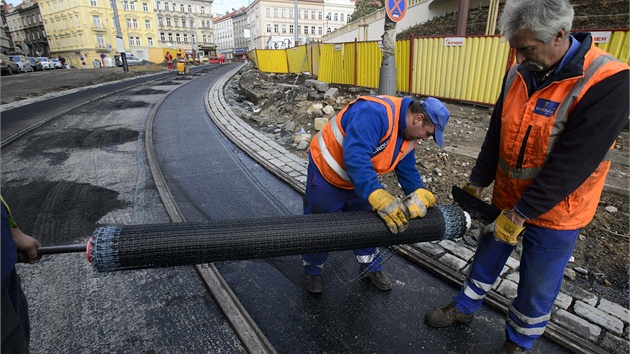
[499,0,573,43]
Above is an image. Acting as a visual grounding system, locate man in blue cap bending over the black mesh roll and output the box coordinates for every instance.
[302,95,450,293]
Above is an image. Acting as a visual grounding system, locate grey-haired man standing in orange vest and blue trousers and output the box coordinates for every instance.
[425,0,630,353]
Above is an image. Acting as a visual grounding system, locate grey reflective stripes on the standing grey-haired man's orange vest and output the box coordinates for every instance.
[499,54,617,180]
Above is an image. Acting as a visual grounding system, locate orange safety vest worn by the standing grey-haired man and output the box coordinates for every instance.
[492,46,627,230]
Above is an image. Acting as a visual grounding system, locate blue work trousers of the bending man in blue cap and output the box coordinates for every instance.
[302,156,382,275]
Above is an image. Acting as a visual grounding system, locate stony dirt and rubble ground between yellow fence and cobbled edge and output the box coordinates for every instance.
[230,66,630,304]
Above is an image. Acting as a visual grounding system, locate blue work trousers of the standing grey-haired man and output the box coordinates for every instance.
[454,225,579,349]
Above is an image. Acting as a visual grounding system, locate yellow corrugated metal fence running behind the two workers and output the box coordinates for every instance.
[252,30,630,105]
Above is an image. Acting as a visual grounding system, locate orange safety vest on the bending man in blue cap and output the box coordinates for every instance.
[309,95,417,189]
